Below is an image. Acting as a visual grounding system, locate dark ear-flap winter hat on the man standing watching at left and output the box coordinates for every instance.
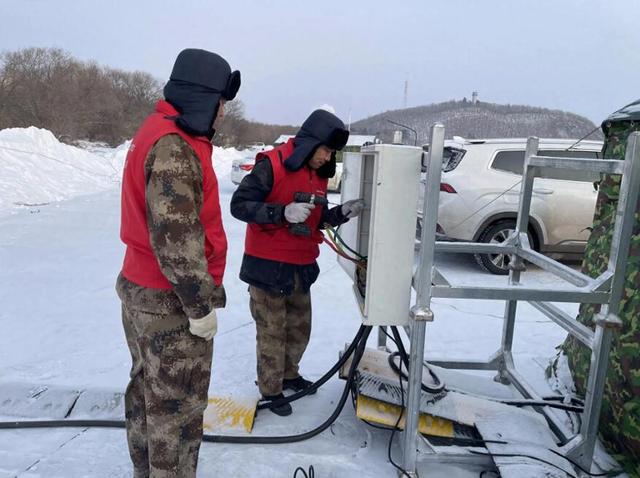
[164,48,240,139]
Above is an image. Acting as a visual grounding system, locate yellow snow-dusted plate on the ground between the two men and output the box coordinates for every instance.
[204,397,258,433]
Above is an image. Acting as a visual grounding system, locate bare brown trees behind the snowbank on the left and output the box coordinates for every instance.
[0,48,296,147]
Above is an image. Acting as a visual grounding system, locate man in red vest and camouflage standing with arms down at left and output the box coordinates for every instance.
[116,49,240,478]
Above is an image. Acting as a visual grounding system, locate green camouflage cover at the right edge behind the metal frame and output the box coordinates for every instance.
[563,121,640,476]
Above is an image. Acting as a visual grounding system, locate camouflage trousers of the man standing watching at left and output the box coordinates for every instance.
[122,304,213,478]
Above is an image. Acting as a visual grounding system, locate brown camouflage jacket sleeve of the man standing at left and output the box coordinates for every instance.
[145,134,218,318]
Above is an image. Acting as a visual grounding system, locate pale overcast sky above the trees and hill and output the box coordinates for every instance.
[0,0,640,126]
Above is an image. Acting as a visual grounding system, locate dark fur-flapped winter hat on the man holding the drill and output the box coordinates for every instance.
[284,110,349,178]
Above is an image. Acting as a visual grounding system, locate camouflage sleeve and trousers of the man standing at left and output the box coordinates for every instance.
[116,130,226,478]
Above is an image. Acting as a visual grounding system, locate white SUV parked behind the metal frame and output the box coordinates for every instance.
[418,138,603,274]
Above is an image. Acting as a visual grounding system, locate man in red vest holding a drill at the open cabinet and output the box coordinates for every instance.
[231,110,363,416]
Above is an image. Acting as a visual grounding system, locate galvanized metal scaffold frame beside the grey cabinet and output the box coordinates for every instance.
[403,123,640,476]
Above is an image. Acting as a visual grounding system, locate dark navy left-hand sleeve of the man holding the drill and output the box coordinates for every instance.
[231,159,285,224]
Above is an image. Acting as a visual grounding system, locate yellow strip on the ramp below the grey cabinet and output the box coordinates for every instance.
[356,395,454,438]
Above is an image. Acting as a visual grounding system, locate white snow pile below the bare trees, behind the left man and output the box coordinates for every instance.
[0,126,245,211]
